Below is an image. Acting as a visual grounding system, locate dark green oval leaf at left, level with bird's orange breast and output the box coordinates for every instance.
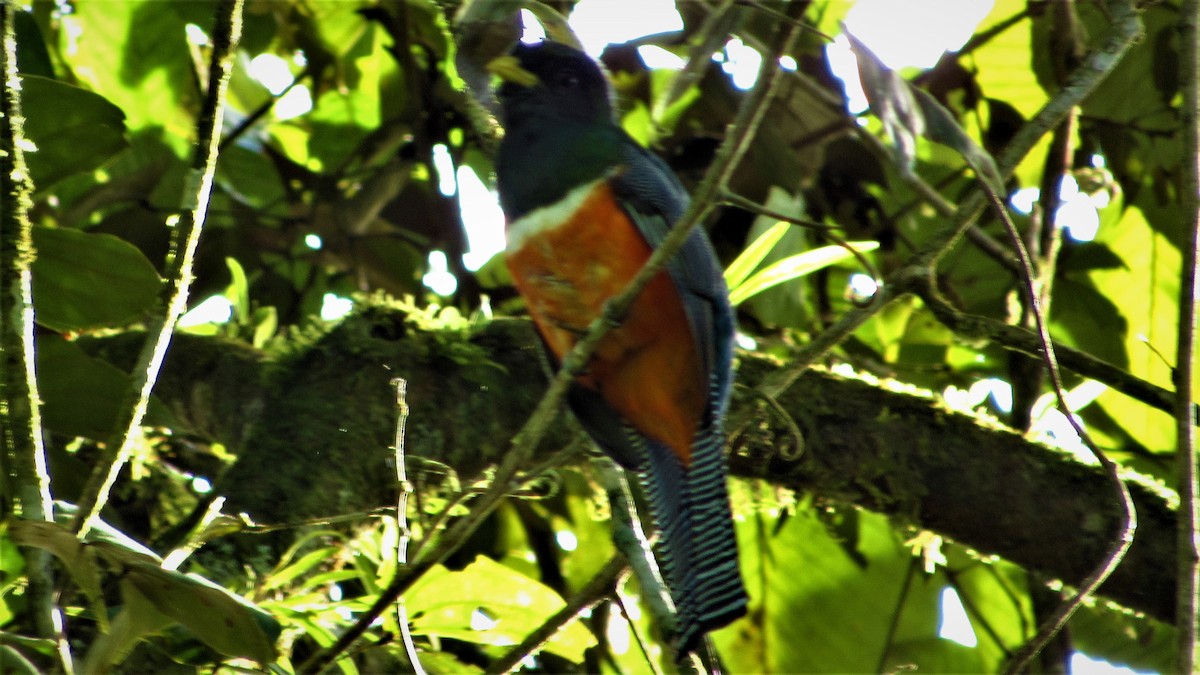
[32,227,161,331]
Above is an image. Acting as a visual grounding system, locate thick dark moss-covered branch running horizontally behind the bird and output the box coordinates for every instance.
[75,310,1176,621]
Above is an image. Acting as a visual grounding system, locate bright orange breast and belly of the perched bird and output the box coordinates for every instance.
[506,181,707,465]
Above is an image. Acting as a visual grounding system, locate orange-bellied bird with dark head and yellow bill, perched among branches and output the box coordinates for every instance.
[488,41,749,656]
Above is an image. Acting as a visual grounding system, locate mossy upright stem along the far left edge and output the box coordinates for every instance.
[0,0,62,673]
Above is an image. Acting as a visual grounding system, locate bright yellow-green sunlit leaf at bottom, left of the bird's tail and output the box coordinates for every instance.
[404,556,595,663]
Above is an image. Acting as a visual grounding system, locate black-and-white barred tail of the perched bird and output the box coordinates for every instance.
[638,431,748,655]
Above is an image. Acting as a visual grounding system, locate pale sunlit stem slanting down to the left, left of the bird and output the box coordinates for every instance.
[72,0,242,538]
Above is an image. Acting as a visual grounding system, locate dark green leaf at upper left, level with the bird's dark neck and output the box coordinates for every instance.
[20,74,128,191]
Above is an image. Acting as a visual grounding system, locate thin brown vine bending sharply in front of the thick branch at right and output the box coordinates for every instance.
[979,181,1138,673]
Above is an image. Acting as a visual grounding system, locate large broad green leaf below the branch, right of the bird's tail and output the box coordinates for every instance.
[713,507,941,673]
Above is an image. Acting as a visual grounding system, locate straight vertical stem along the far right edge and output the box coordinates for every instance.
[1175,0,1200,673]
